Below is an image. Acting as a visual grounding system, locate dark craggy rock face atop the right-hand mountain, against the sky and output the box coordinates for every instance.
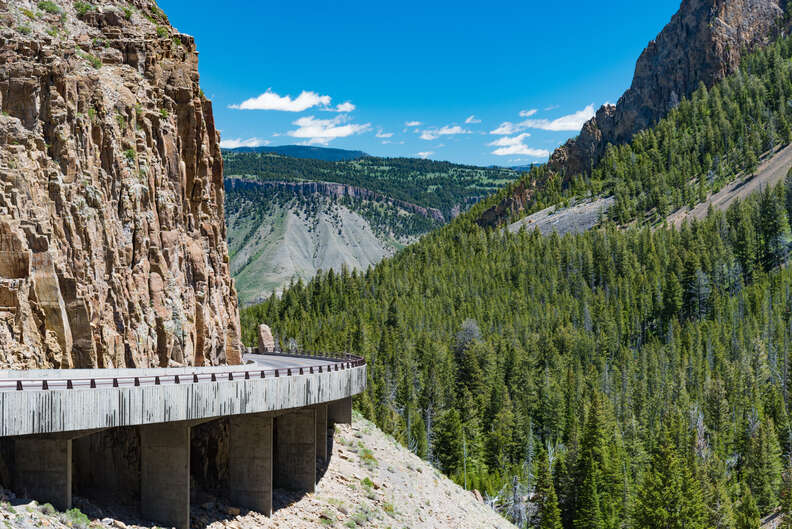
[549,0,787,175]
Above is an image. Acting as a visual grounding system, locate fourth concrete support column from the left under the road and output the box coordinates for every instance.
[275,408,316,492]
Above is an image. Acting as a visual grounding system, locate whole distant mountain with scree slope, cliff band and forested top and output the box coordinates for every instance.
[223,151,517,305]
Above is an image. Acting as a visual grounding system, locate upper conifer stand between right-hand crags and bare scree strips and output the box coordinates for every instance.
[492,37,792,228]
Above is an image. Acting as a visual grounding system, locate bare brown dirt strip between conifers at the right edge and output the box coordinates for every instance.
[668,144,792,226]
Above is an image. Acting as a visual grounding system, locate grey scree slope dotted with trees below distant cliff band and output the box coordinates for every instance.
[226,179,440,306]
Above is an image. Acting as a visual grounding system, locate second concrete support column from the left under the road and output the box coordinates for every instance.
[140,422,190,529]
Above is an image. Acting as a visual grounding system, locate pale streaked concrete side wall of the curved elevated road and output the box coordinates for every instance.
[0,366,366,437]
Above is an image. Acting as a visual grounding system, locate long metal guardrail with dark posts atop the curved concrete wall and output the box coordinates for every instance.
[0,353,366,391]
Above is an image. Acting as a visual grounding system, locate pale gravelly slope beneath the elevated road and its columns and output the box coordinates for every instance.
[0,419,514,529]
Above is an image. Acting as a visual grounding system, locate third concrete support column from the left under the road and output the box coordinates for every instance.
[228,413,272,516]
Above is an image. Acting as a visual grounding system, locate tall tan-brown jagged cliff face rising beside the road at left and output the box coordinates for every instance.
[0,0,240,368]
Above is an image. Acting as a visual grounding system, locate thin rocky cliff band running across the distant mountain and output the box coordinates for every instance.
[226,178,446,222]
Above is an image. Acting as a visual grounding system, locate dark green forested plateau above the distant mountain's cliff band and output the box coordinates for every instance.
[223,151,518,219]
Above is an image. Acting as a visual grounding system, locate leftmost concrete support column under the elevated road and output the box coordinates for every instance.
[14,438,72,511]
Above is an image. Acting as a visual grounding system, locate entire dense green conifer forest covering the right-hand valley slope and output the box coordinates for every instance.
[242,24,792,529]
